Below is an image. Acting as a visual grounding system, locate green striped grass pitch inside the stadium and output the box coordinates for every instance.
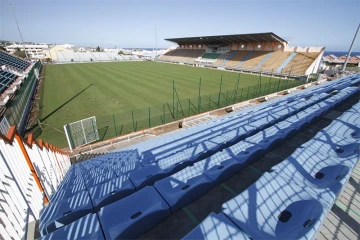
[39,61,292,147]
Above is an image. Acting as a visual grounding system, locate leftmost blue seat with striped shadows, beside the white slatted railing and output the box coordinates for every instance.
[39,191,93,236]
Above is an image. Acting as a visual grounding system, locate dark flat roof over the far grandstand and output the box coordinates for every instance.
[165,32,286,45]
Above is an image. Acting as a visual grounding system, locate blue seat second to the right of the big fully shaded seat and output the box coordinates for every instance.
[193,149,247,185]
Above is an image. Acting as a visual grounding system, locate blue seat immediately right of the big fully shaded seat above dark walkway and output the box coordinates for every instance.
[154,167,213,213]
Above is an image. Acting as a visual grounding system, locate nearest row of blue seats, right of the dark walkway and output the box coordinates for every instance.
[184,103,360,239]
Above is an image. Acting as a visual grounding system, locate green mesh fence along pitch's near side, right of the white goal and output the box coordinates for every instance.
[96,74,318,140]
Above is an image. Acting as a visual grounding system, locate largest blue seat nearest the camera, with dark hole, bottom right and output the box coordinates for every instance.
[222,173,328,239]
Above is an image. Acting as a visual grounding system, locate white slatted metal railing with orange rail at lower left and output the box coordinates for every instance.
[0,126,70,239]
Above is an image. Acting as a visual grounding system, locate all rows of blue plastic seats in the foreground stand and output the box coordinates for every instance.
[39,75,360,239]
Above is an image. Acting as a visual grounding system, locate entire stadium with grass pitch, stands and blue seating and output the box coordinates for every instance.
[0,4,360,240]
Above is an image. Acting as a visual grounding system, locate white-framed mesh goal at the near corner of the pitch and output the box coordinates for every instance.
[64,116,99,151]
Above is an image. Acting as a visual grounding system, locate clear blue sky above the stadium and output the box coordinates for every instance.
[0,0,360,51]
